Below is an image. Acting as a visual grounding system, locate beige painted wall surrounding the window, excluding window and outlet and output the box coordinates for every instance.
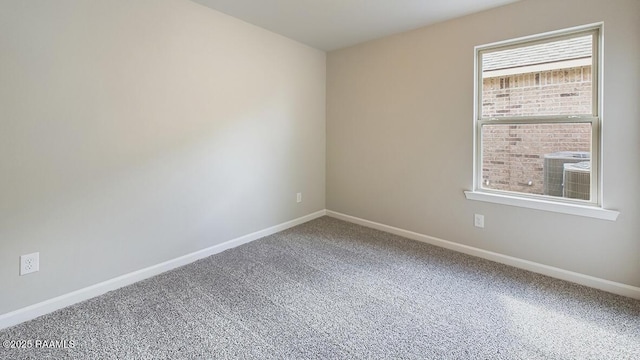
[327,0,640,286]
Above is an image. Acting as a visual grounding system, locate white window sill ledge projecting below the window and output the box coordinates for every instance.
[464,191,620,221]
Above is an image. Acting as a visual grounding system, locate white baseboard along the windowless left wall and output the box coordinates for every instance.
[0,210,326,330]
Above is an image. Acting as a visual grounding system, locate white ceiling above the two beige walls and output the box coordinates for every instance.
[192,0,519,51]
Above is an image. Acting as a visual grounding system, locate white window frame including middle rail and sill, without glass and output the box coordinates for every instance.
[465,23,619,221]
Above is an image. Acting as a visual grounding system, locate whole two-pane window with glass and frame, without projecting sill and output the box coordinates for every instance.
[468,25,601,211]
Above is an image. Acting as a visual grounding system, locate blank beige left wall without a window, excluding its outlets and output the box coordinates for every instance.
[0,0,326,314]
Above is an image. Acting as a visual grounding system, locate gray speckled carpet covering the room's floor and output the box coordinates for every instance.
[0,217,640,359]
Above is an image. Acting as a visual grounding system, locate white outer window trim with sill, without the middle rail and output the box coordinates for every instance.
[464,23,620,221]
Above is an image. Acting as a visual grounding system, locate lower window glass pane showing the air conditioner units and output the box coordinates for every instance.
[482,123,591,200]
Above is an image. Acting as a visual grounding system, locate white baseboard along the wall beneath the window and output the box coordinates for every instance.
[327,210,640,299]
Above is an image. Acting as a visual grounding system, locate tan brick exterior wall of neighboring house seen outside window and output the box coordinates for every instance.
[482,66,592,194]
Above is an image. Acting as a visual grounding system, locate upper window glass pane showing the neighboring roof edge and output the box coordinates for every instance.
[481,35,593,118]
